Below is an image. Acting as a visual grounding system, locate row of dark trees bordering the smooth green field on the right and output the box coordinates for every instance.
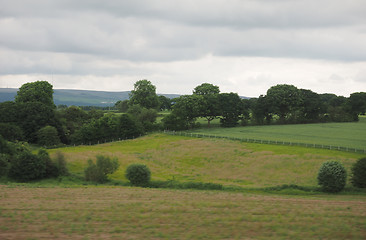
[162,83,366,130]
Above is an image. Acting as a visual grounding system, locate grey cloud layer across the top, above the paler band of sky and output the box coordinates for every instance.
[0,0,366,65]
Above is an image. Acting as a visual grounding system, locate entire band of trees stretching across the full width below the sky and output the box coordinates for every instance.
[0,80,366,147]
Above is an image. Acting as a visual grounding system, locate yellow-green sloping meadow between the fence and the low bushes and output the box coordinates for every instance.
[51,134,363,187]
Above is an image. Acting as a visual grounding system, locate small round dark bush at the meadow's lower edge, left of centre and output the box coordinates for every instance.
[126,163,151,186]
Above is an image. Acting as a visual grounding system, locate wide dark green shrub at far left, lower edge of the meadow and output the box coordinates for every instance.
[8,151,46,182]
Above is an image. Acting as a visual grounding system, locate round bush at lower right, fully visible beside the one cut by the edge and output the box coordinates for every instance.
[318,161,347,192]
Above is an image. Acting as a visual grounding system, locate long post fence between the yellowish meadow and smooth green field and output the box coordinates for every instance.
[164,131,366,154]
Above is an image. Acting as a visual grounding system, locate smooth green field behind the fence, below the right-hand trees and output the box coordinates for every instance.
[189,117,366,149]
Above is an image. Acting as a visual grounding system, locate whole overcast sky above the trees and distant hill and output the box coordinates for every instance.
[0,0,366,97]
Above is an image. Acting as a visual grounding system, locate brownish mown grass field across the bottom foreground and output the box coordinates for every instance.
[0,186,366,239]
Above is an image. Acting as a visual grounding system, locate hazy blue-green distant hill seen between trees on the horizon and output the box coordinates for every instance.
[0,88,179,107]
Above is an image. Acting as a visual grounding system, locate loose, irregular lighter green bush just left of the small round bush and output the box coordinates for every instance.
[84,155,119,183]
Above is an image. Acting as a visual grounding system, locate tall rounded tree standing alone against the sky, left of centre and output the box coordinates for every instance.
[129,79,159,109]
